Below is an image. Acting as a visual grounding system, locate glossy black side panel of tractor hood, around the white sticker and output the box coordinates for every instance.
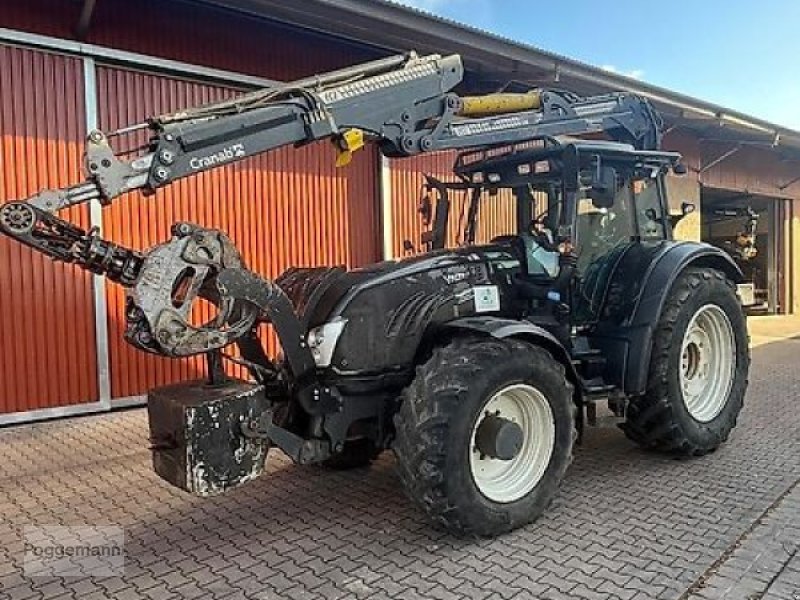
[331,246,522,375]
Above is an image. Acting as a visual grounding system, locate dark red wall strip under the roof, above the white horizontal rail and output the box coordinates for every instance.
[0,0,378,80]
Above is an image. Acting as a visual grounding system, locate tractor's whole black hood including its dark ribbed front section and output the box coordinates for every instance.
[276,245,519,375]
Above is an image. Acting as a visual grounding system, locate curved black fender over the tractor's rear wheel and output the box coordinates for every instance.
[621,242,744,395]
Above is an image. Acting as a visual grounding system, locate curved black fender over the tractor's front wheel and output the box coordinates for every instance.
[439,316,583,403]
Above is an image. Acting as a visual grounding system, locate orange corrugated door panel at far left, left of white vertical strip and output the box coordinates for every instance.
[0,45,98,413]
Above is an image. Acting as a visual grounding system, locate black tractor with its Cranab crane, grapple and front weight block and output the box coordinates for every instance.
[0,54,750,535]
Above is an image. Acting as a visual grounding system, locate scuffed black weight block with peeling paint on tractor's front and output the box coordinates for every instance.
[147,380,269,496]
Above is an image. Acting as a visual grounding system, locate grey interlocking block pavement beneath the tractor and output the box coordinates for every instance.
[0,341,800,600]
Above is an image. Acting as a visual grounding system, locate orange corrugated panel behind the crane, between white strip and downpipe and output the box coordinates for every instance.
[98,67,378,397]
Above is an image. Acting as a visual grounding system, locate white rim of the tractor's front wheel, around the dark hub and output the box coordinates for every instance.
[470,384,556,503]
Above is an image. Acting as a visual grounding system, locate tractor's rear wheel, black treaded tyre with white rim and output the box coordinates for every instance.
[622,268,750,456]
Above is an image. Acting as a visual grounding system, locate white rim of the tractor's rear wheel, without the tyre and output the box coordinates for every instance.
[679,304,736,423]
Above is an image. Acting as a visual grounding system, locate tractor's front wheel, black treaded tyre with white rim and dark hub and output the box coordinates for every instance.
[394,337,575,536]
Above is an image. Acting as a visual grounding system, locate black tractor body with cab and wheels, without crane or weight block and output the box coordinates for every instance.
[268,139,749,535]
